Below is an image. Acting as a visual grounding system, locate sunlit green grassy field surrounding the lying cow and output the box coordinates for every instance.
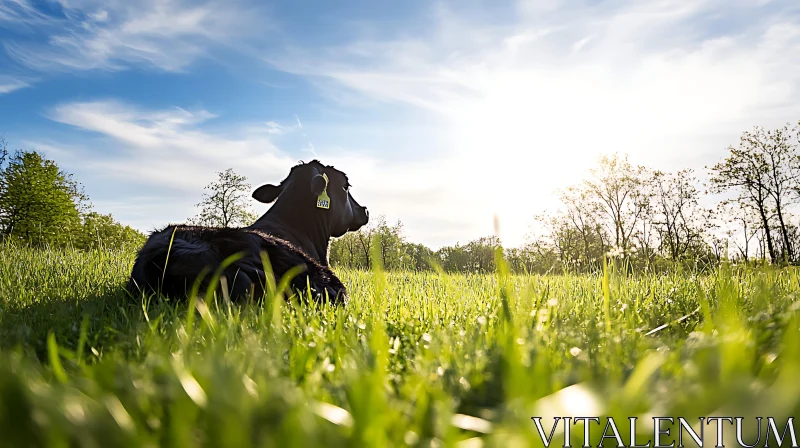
[0,246,800,447]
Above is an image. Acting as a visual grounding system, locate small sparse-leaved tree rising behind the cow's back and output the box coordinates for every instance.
[189,168,256,227]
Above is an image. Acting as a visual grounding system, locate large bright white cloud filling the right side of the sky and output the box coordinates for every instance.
[269,0,800,245]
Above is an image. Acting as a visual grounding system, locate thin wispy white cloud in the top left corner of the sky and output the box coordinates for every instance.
[0,0,269,72]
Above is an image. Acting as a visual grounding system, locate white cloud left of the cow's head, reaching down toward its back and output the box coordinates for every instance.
[34,100,297,230]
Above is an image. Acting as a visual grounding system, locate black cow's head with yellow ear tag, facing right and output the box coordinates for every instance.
[253,160,369,237]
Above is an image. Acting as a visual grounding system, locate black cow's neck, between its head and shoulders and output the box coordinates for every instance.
[250,203,330,266]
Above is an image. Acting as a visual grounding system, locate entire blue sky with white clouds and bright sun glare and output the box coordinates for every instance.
[0,0,800,249]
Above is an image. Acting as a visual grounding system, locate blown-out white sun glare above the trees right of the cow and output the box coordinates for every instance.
[445,35,784,245]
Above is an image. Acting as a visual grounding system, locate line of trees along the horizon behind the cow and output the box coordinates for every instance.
[0,122,800,273]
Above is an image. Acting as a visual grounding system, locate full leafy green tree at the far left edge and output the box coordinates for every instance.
[0,151,86,244]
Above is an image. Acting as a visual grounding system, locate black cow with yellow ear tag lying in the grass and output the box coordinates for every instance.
[128,160,369,303]
